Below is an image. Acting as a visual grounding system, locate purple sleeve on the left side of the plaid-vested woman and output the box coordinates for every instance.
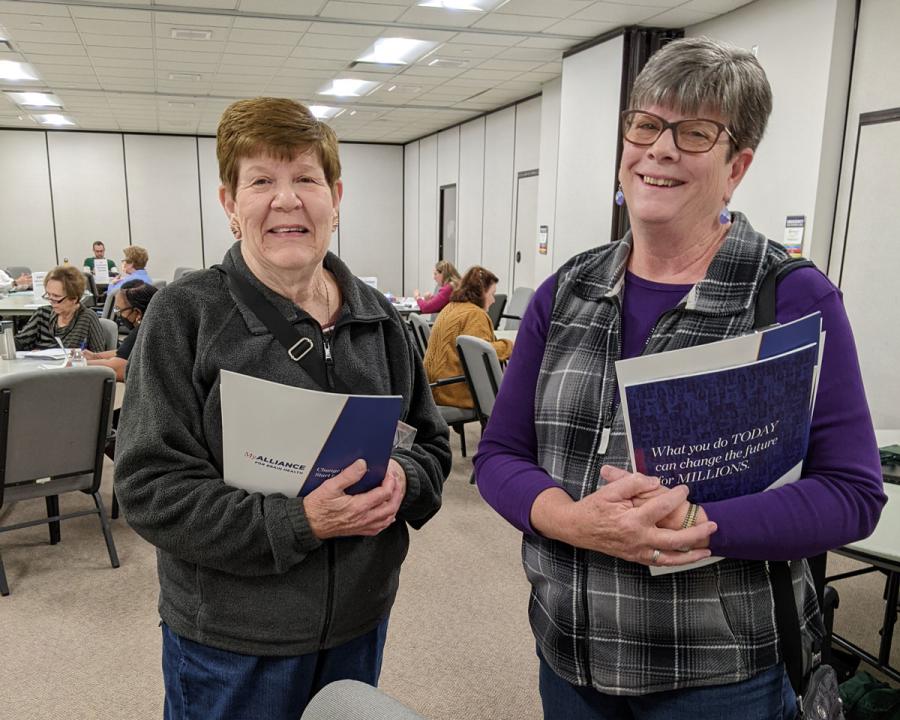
[474,277,559,534]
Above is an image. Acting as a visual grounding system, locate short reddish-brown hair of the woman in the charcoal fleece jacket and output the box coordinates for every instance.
[216,97,341,197]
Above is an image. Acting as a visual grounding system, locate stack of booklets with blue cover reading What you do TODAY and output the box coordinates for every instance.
[616,313,825,575]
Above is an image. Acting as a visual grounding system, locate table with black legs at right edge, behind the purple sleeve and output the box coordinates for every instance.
[826,430,900,682]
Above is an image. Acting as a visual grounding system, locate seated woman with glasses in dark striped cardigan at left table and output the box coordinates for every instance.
[16,265,106,351]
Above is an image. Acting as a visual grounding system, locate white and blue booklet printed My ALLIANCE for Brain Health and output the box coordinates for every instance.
[220,370,403,497]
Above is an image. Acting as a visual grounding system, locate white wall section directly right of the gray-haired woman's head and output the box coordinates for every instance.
[685,0,854,268]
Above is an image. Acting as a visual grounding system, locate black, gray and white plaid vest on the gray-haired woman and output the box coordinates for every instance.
[522,213,823,695]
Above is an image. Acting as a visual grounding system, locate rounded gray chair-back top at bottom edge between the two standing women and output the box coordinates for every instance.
[300,680,425,720]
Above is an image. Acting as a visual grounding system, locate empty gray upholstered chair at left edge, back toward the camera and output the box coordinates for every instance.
[0,367,119,595]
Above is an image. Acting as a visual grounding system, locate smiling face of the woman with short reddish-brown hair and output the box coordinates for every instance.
[219,151,343,280]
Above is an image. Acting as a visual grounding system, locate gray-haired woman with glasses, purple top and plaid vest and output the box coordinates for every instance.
[475,38,885,720]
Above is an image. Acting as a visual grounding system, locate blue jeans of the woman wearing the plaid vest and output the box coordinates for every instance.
[538,653,797,720]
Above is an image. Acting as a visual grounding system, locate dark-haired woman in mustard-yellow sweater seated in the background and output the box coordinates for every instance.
[425,265,512,408]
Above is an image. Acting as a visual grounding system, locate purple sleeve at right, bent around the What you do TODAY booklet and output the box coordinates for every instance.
[703,268,887,560]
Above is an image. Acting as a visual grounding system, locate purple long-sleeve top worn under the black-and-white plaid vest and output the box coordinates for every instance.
[475,268,886,560]
